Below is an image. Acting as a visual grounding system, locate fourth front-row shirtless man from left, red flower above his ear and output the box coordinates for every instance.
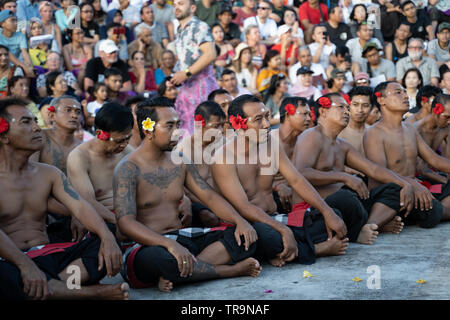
[294,93,412,244]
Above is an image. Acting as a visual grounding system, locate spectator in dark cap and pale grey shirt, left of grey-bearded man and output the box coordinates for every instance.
[361,42,396,83]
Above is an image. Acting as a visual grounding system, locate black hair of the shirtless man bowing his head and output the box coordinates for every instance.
[94,102,134,132]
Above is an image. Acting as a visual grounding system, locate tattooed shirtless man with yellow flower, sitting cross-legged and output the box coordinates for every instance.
[113,98,261,291]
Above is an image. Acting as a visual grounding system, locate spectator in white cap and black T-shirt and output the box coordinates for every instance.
[84,40,132,92]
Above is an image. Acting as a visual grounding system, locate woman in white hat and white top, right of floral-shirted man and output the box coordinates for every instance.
[230,43,258,94]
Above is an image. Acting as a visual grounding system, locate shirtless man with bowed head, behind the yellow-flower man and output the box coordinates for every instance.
[67,102,133,230]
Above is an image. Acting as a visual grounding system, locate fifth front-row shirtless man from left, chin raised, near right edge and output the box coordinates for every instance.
[364,82,450,228]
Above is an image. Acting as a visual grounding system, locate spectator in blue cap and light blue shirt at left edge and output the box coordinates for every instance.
[0,10,35,78]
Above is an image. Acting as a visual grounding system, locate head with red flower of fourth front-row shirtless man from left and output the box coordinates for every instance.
[316,93,350,130]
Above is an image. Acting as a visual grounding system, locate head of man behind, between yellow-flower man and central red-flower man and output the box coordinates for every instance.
[194,100,227,139]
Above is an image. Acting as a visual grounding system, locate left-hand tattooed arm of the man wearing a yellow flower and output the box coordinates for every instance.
[113,159,196,277]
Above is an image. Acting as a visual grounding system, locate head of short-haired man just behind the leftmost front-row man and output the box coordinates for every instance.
[50,96,82,132]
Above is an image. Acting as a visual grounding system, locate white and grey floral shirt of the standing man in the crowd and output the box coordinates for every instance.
[175,16,214,71]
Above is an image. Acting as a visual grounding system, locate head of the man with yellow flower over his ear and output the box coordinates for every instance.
[136,97,180,151]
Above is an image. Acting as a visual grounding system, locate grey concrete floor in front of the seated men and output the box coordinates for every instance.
[103,223,450,300]
